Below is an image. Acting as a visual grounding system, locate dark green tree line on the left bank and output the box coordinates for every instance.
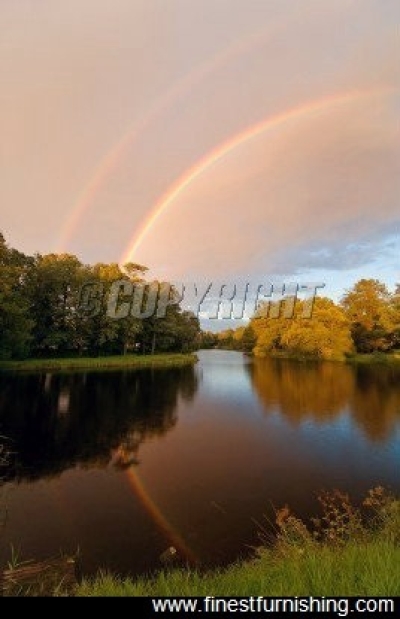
[0,233,200,359]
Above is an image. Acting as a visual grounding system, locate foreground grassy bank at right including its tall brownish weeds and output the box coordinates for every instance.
[76,488,400,596]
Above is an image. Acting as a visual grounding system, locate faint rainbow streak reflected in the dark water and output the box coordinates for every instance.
[126,467,197,564]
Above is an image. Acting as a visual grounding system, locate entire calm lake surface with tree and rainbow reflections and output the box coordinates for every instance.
[0,351,400,574]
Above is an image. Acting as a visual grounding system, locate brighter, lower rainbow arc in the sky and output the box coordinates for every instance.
[120,87,394,265]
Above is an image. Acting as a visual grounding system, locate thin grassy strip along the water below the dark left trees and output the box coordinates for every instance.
[0,353,197,372]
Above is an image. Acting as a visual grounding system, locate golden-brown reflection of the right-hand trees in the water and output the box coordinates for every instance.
[245,359,400,441]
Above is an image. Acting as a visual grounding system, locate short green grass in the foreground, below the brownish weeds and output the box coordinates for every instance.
[76,540,400,596]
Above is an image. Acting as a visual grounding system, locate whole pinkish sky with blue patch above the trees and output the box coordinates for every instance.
[0,0,400,300]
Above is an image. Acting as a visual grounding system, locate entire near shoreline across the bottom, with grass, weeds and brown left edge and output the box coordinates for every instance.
[0,486,400,597]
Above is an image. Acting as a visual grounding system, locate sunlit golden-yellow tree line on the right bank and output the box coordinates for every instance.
[203,279,400,359]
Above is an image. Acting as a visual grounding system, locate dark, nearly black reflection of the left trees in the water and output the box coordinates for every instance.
[0,367,197,479]
